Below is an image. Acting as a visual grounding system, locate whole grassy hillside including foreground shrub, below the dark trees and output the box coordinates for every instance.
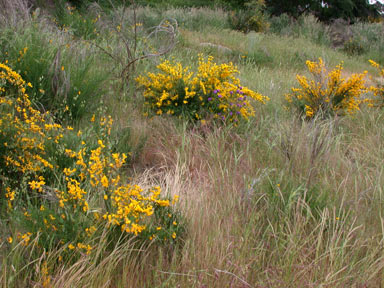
[0,1,384,287]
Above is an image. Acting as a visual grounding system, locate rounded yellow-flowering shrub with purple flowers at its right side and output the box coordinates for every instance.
[136,55,269,122]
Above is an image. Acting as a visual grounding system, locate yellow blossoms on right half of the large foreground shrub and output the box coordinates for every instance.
[63,118,170,235]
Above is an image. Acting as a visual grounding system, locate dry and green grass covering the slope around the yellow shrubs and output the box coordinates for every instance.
[0,1,384,288]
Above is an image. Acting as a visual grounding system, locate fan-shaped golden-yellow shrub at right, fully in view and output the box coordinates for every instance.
[286,58,367,119]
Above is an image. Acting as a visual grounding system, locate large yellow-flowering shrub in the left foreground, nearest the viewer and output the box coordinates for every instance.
[0,63,183,254]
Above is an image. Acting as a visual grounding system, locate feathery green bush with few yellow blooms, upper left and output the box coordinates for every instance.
[0,22,106,121]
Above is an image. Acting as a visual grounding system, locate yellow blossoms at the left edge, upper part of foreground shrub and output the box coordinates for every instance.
[0,63,66,184]
